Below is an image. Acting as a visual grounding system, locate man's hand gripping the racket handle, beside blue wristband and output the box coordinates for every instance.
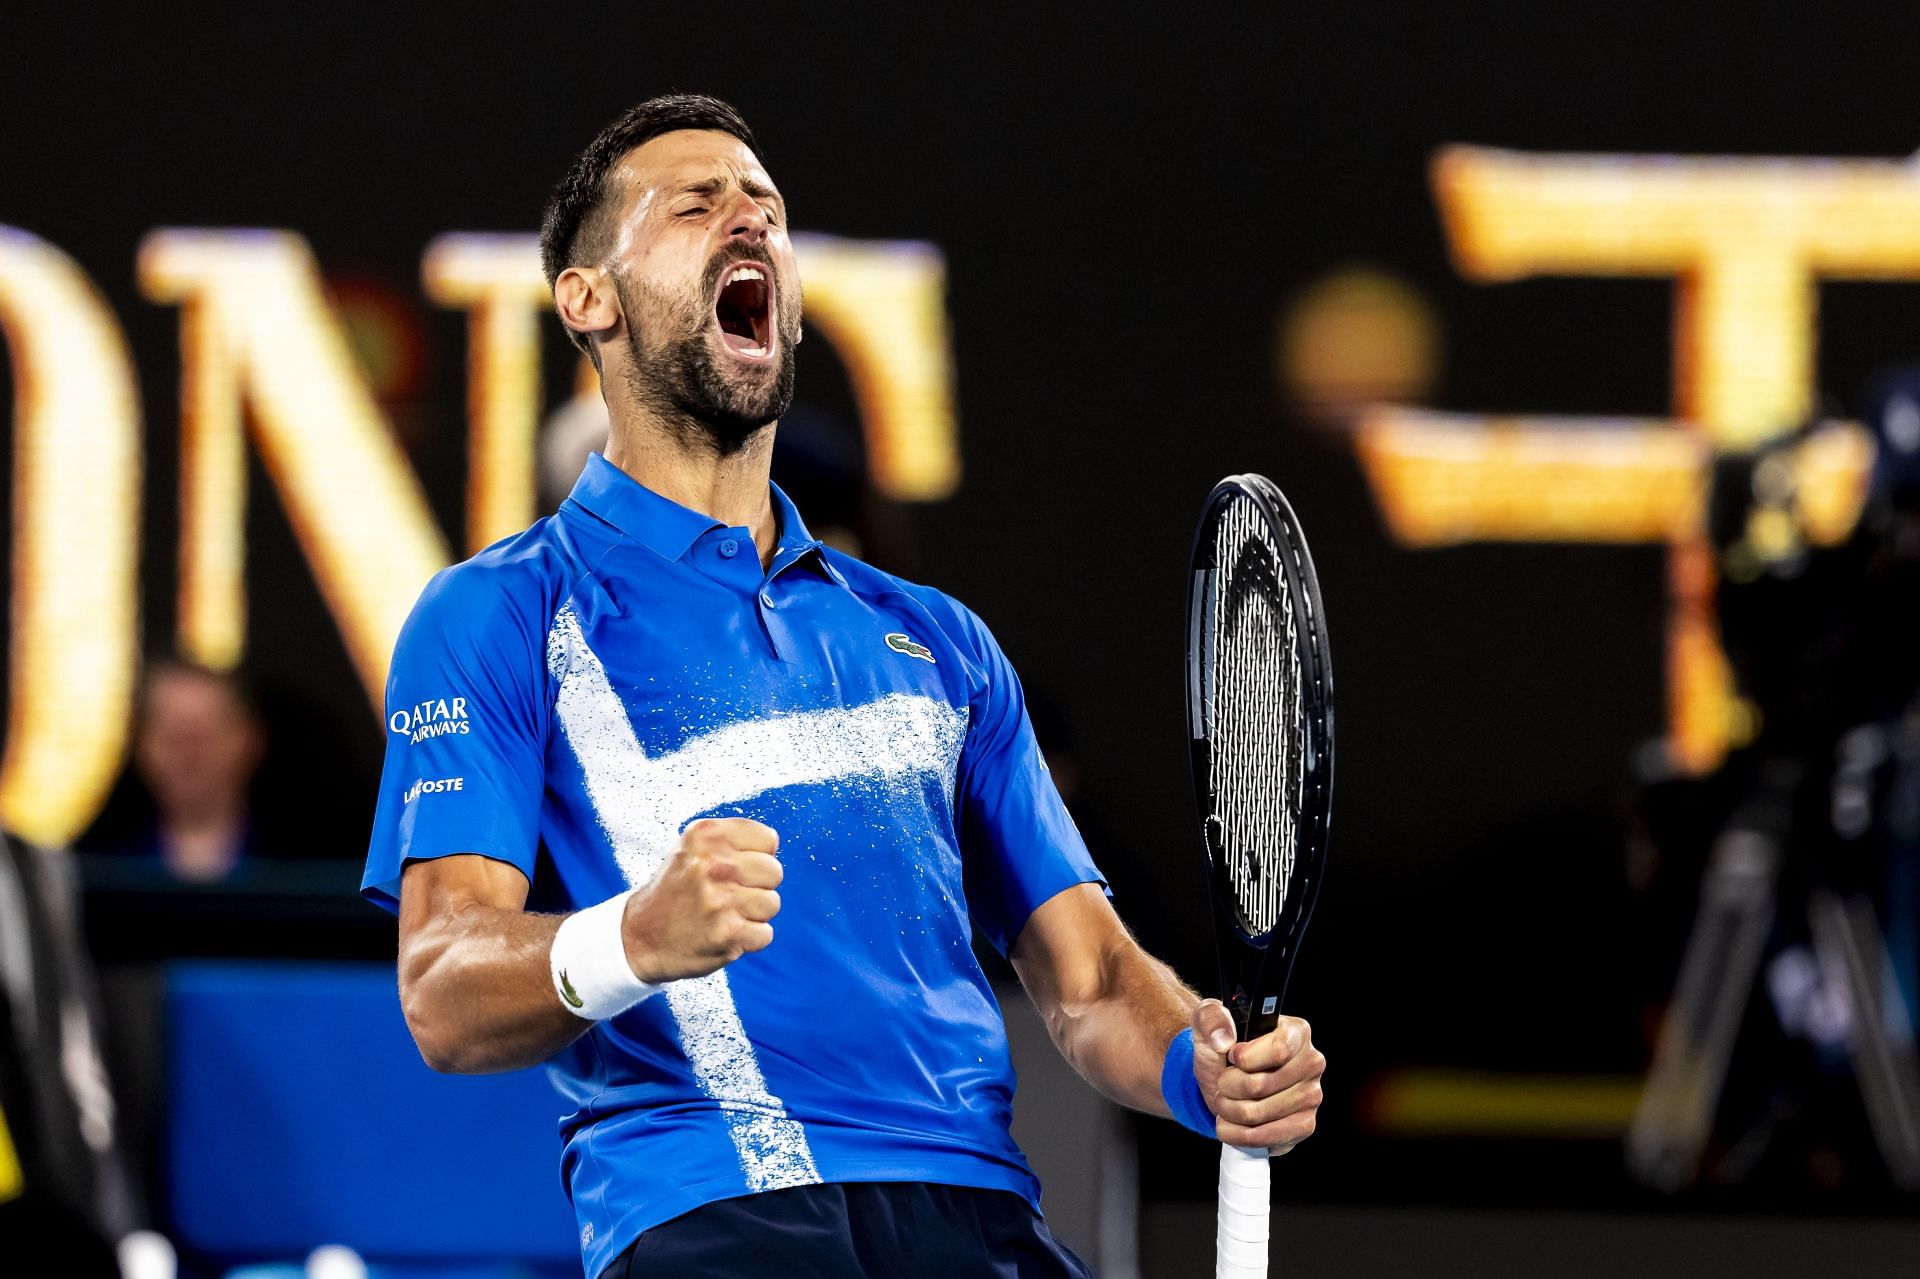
[1192,999,1327,1154]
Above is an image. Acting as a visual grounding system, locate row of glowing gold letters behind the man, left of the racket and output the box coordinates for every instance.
[0,227,960,843]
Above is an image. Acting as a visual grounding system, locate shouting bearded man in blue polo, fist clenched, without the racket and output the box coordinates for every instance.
[363,96,1325,1279]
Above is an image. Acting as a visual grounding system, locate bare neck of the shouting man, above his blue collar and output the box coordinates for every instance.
[607,395,780,567]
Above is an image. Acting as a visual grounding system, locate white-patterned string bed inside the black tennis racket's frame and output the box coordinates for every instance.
[1210,497,1306,935]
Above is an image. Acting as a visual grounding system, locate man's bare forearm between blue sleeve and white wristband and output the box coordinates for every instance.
[399,903,589,1075]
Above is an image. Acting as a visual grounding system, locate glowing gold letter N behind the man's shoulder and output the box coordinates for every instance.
[140,230,449,707]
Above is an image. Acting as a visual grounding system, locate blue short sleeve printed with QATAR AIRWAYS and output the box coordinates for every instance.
[361,563,549,912]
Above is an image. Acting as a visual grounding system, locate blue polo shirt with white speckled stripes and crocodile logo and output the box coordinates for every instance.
[361,455,1100,1275]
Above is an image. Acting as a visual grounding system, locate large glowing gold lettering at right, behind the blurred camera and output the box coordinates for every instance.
[1357,148,1920,770]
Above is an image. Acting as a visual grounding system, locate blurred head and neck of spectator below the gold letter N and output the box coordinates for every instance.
[92,659,267,883]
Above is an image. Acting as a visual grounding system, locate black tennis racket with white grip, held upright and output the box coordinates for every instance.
[1187,474,1332,1279]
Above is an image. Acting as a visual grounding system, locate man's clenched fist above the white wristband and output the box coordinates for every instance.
[620,818,785,983]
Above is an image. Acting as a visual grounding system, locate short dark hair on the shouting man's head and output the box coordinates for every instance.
[540,94,764,353]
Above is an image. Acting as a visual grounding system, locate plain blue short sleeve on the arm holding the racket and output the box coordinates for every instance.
[956,609,1106,954]
